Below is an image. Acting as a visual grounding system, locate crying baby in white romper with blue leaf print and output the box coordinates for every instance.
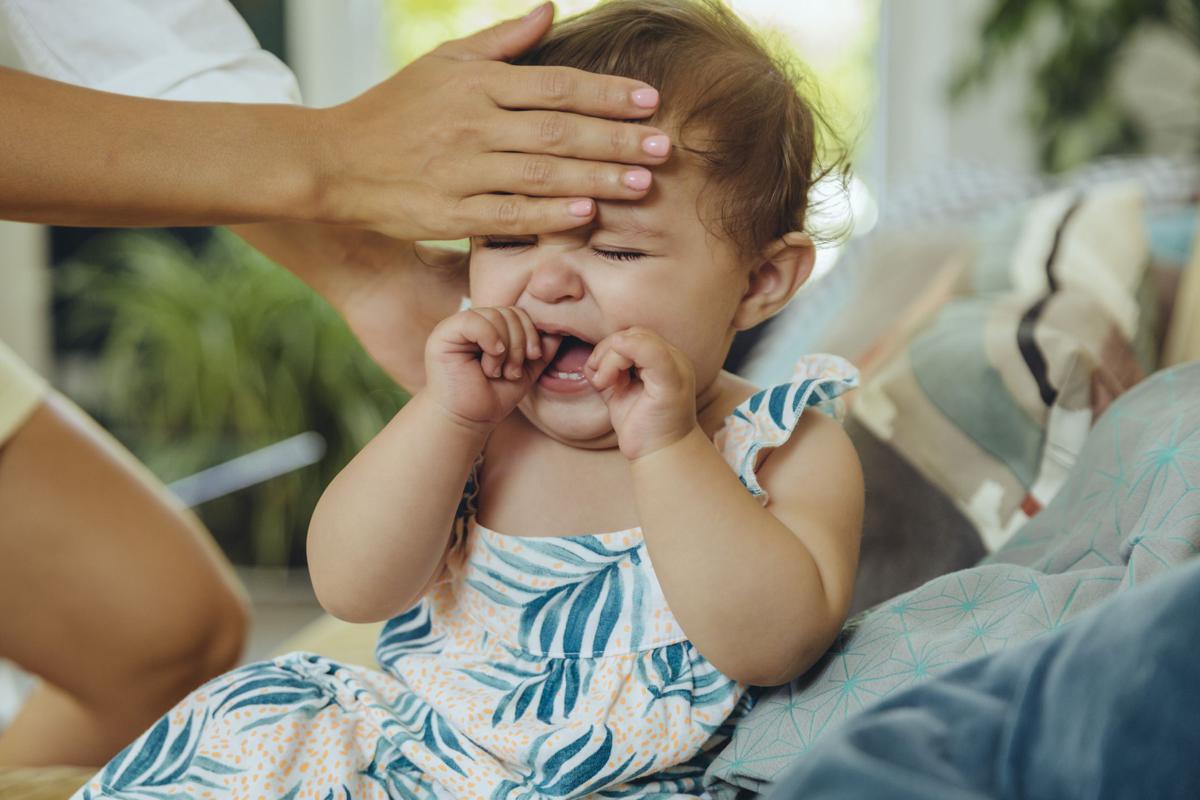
[75,0,863,799]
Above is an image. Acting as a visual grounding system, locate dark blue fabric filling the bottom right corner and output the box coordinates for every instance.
[769,559,1200,800]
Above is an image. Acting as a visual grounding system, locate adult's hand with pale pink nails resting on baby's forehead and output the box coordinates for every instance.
[322,4,670,241]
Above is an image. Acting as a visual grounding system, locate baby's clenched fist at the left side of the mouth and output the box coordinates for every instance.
[425,308,562,432]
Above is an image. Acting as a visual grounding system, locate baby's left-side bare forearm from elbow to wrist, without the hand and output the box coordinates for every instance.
[308,395,486,622]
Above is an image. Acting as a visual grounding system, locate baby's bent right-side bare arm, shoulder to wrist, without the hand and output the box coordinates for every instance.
[631,411,863,686]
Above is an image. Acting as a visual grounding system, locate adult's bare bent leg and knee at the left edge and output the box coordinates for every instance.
[0,393,247,765]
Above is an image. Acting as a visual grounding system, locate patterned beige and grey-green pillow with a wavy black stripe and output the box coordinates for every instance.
[851,185,1148,556]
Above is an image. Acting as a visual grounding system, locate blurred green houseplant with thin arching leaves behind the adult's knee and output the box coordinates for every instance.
[58,229,406,566]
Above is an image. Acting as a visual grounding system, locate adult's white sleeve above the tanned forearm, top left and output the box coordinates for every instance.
[0,0,300,103]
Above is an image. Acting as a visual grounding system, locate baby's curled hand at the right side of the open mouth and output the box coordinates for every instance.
[583,326,696,461]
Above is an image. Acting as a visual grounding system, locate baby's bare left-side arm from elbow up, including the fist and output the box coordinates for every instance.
[308,308,559,622]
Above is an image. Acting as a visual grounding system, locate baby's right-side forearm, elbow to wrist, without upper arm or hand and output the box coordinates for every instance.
[631,428,840,685]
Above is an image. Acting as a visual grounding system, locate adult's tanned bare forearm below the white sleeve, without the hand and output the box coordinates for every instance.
[0,68,323,227]
